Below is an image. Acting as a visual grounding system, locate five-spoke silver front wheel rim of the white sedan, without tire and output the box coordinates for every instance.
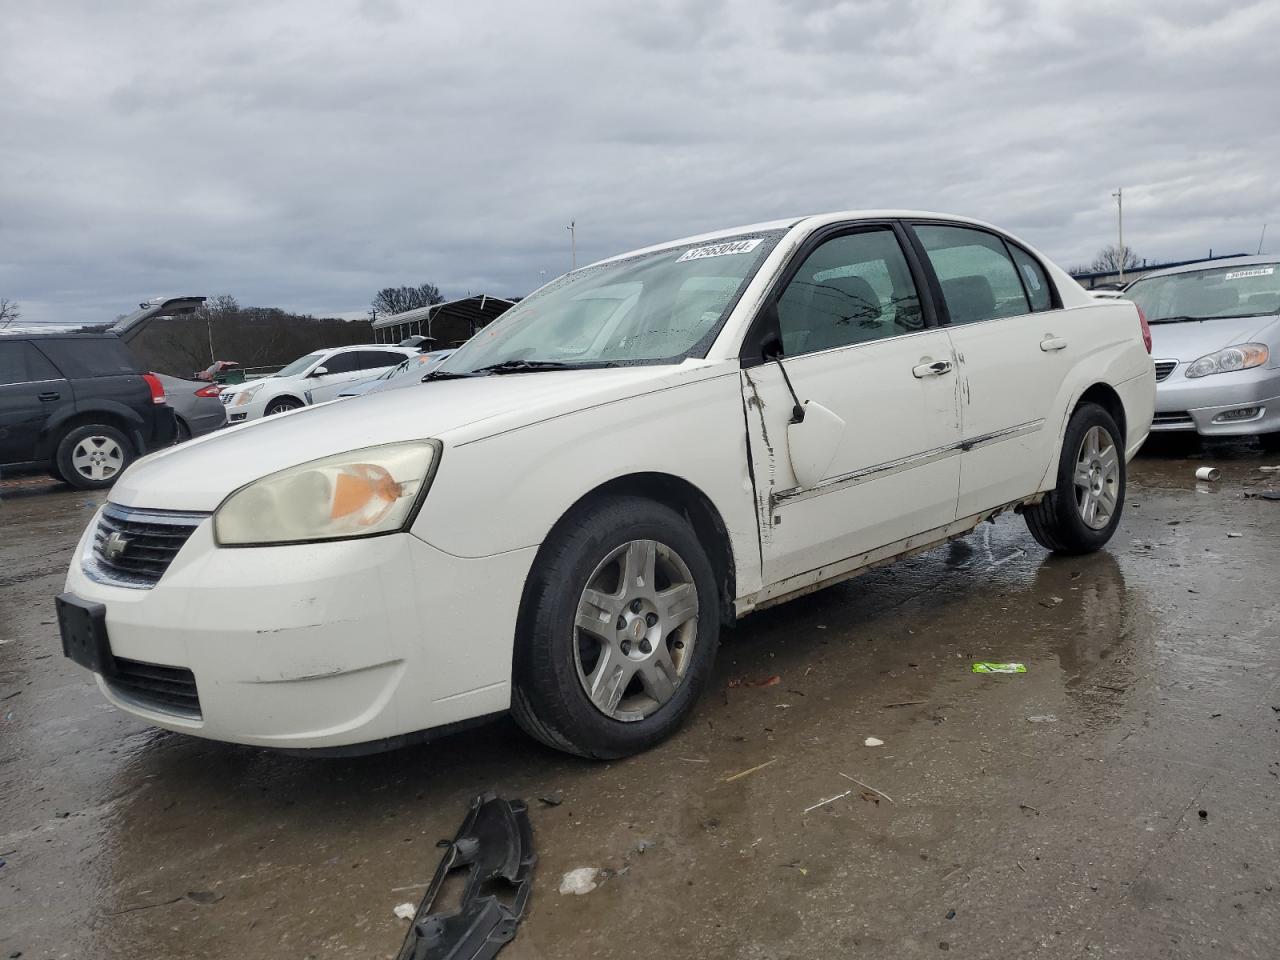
[573,540,698,722]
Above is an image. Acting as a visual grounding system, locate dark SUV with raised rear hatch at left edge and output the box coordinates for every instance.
[0,333,175,490]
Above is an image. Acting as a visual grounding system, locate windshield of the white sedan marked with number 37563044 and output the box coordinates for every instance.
[439,230,785,374]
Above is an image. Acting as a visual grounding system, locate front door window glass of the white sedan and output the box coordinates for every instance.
[778,228,924,357]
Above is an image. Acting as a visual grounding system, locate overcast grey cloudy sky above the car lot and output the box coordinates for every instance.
[0,0,1280,321]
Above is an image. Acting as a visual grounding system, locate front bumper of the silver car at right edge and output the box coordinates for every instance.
[1151,364,1280,436]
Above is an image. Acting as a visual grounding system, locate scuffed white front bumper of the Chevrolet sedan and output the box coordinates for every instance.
[67,517,536,749]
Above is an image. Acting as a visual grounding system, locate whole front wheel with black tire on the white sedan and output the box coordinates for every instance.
[512,497,721,759]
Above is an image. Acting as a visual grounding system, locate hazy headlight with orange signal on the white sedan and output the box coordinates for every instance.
[214,440,440,547]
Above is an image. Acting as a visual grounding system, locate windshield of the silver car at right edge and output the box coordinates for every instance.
[1124,264,1280,324]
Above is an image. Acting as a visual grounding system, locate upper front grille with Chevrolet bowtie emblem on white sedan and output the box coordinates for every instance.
[84,503,207,590]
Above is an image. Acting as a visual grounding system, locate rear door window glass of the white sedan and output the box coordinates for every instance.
[915,224,1029,324]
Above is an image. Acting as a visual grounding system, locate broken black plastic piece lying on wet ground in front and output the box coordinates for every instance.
[398,794,538,960]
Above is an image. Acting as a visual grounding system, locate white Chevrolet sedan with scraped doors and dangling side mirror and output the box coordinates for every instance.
[58,211,1155,758]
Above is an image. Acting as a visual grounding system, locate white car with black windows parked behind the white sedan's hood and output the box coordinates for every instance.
[220,343,419,424]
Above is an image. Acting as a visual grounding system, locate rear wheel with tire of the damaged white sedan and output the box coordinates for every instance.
[1023,403,1126,554]
